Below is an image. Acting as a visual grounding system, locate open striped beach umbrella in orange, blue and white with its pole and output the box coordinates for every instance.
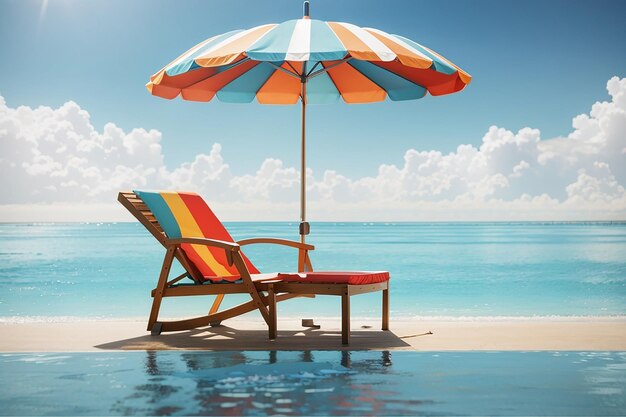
[146,1,471,243]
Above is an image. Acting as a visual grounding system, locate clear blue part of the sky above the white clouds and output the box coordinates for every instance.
[0,0,626,178]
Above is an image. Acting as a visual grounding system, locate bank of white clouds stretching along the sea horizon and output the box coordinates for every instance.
[0,77,626,221]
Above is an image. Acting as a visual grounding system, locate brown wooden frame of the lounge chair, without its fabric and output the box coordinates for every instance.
[117,191,389,345]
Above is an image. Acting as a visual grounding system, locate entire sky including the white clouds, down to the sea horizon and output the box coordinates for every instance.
[0,0,626,221]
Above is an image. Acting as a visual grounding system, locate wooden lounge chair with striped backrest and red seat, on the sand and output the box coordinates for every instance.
[118,191,389,344]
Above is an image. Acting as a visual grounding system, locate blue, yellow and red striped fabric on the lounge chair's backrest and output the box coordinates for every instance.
[133,190,259,282]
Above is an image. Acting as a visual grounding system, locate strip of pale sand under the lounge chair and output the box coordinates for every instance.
[0,316,626,352]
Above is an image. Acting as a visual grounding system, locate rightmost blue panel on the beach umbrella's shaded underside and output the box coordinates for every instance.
[348,59,426,101]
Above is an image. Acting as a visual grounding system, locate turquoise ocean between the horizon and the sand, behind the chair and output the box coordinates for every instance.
[0,222,626,322]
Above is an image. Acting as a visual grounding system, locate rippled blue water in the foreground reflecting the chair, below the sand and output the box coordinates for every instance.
[0,351,626,416]
